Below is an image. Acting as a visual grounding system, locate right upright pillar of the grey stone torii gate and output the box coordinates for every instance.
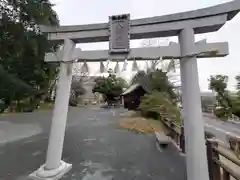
[178,28,209,180]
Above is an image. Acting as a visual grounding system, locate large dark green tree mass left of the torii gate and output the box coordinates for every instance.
[0,0,59,111]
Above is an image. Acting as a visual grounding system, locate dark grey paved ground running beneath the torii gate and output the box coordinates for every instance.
[0,108,186,180]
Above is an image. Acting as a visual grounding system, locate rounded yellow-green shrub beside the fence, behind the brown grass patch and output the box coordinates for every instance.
[139,92,181,123]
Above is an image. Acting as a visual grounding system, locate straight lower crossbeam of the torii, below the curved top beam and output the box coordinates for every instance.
[45,41,229,62]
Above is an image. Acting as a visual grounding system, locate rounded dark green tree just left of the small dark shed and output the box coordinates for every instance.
[92,74,126,101]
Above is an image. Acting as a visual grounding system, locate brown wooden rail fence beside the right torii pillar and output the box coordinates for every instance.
[162,119,240,180]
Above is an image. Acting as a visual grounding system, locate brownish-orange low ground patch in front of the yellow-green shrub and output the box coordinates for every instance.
[119,116,168,134]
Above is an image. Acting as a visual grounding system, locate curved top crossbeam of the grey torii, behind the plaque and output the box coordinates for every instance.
[41,0,240,43]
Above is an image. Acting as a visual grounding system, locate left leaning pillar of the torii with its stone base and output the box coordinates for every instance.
[29,39,75,180]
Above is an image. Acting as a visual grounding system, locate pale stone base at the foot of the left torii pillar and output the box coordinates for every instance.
[28,161,72,180]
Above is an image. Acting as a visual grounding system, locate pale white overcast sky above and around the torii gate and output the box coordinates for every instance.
[52,0,240,91]
